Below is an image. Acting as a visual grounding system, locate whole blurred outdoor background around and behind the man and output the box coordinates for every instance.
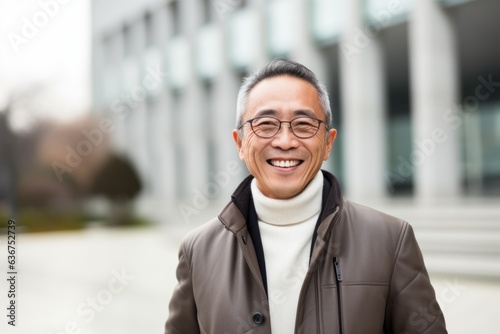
[0,0,500,334]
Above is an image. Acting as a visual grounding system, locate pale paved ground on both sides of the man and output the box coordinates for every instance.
[0,227,500,334]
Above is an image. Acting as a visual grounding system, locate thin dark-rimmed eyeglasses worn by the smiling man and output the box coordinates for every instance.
[238,116,328,139]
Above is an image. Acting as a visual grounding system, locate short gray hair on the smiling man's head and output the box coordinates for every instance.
[236,59,332,128]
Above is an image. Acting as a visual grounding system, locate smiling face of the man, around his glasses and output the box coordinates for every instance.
[233,76,337,199]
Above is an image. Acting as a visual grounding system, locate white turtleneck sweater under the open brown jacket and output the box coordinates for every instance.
[251,171,323,334]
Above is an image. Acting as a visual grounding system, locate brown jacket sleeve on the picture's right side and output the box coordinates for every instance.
[385,222,447,334]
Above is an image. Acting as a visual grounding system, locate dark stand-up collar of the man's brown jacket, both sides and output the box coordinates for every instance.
[219,170,342,234]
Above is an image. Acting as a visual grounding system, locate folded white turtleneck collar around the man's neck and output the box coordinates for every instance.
[251,171,323,225]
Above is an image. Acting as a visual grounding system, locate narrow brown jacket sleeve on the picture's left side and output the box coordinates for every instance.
[165,243,200,334]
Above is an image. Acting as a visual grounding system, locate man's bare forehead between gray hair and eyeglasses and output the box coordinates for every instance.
[247,76,324,119]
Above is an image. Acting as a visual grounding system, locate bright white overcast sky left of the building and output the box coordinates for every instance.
[0,0,91,127]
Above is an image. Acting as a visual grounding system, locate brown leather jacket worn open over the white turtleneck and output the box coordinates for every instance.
[165,171,447,334]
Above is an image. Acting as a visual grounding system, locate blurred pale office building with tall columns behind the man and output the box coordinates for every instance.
[92,0,500,219]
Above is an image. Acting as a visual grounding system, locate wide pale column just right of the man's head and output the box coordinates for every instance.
[338,0,387,199]
